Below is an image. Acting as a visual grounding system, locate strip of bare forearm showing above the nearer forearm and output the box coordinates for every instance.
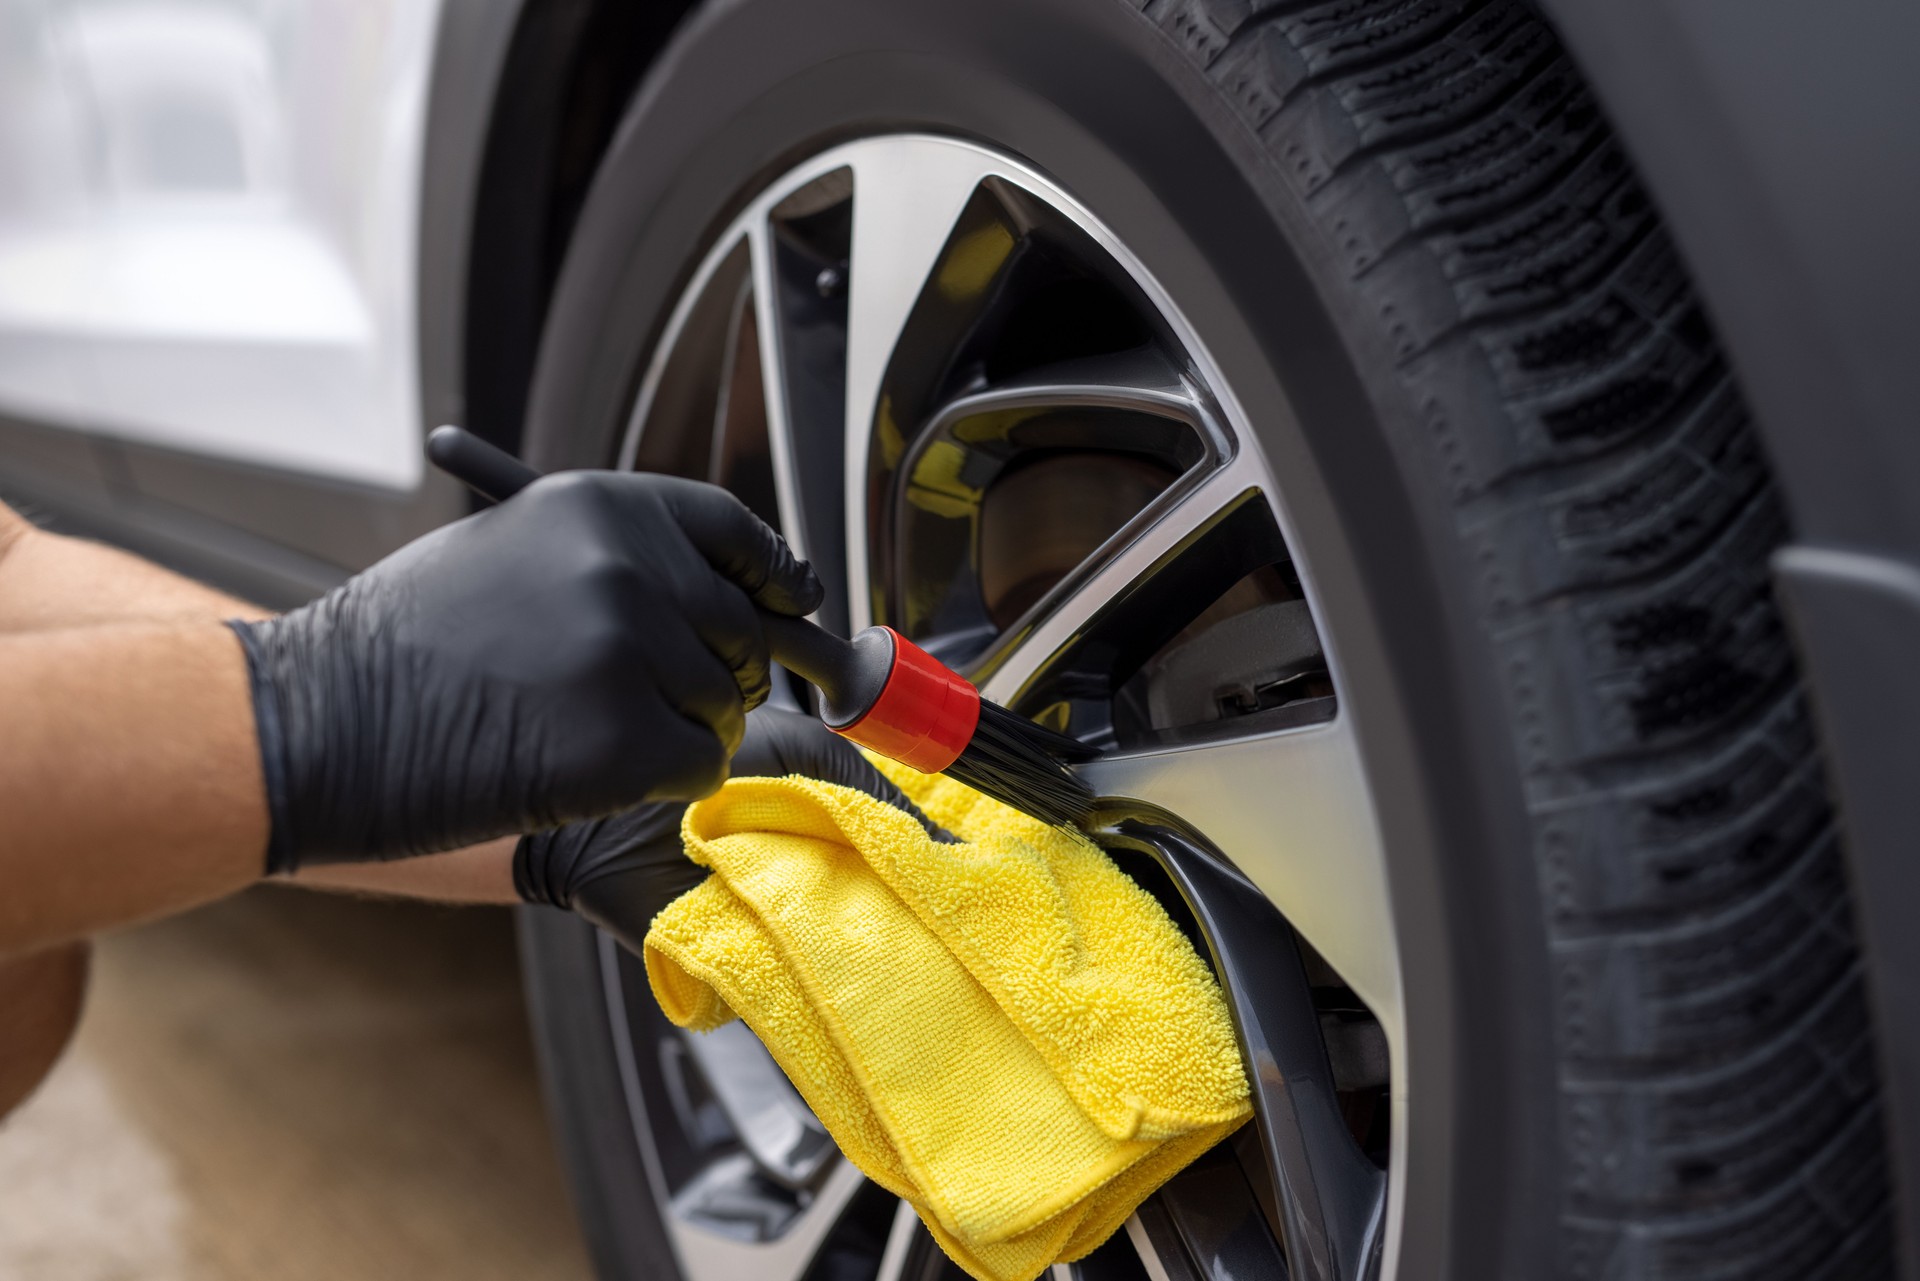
[0,503,267,634]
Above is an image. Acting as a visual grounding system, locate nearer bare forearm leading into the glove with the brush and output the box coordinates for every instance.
[0,620,267,956]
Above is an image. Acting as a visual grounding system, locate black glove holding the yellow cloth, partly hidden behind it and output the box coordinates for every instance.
[513,707,952,953]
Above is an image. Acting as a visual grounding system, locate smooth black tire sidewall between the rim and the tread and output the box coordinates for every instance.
[526,0,1561,1279]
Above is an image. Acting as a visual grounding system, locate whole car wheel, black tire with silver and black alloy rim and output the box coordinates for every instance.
[522,0,1887,1281]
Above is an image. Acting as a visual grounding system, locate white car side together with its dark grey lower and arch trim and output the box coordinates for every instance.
[0,0,520,607]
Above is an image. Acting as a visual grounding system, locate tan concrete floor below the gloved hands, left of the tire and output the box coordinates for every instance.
[0,889,589,1281]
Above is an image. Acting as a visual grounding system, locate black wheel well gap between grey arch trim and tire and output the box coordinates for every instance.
[461,0,699,459]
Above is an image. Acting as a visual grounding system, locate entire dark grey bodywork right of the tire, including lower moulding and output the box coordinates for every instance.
[1540,0,1920,1275]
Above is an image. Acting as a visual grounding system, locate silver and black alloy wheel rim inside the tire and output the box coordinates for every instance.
[601,134,1405,1281]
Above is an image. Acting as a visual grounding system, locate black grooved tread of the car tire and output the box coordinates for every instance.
[1142,0,1891,1281]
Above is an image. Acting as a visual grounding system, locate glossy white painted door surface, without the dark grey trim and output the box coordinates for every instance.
[0,0,442,490]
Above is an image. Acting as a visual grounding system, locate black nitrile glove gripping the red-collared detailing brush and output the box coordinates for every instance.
[232,472,820,872]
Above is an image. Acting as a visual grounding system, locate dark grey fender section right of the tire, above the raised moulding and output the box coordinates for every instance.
[1536,0,1920,557]
